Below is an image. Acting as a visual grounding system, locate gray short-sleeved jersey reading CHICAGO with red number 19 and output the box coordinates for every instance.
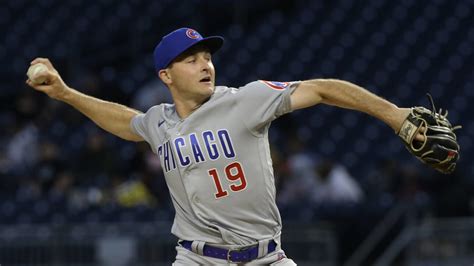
[131,81,297,245]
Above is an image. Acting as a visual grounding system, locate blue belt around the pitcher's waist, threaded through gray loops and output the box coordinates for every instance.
[179,240,277,262]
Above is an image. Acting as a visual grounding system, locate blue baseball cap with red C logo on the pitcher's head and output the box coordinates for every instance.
[153,28,224,71]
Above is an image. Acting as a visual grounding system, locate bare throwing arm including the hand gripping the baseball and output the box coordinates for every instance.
[26,58,143,141]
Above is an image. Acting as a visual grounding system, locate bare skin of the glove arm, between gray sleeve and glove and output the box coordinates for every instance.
[291,79,410,133]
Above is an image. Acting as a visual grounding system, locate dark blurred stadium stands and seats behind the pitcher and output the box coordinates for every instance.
[0,0,474,266]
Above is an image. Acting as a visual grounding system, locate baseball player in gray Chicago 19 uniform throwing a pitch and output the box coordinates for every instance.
[27,28,459,265]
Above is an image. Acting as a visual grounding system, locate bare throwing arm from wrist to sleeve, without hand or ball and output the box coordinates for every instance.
[58,89,143,141]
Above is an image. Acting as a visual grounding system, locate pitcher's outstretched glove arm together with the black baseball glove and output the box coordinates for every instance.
[291,79,461,174]
